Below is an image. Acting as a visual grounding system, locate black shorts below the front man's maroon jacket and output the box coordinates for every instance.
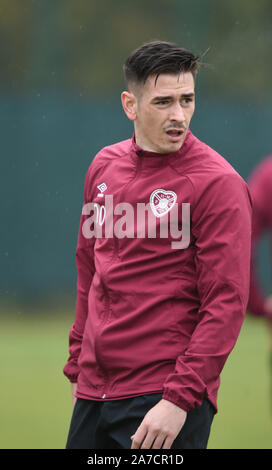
[66,393,215,449]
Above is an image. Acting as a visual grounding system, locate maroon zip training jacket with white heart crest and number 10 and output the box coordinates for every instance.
[64,131,251,411]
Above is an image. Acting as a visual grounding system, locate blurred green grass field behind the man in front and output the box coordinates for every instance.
[0,302,272,449]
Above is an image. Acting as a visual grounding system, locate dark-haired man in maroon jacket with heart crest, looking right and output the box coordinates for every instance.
[64,41,251,449]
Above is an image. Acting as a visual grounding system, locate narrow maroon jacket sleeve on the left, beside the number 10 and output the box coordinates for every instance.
[63,169,95,382]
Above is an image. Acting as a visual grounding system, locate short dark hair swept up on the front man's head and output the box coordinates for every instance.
[123,40,201,88]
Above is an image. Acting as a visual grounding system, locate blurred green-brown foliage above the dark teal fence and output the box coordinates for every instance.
[0,0,272,94]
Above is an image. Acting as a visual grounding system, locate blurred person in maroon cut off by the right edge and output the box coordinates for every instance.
[248,155,272,324]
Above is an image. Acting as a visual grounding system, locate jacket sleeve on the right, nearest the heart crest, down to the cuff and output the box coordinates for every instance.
[163,173,252,411]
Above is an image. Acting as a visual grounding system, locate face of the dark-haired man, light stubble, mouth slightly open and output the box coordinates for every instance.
[134,72,195,153]
